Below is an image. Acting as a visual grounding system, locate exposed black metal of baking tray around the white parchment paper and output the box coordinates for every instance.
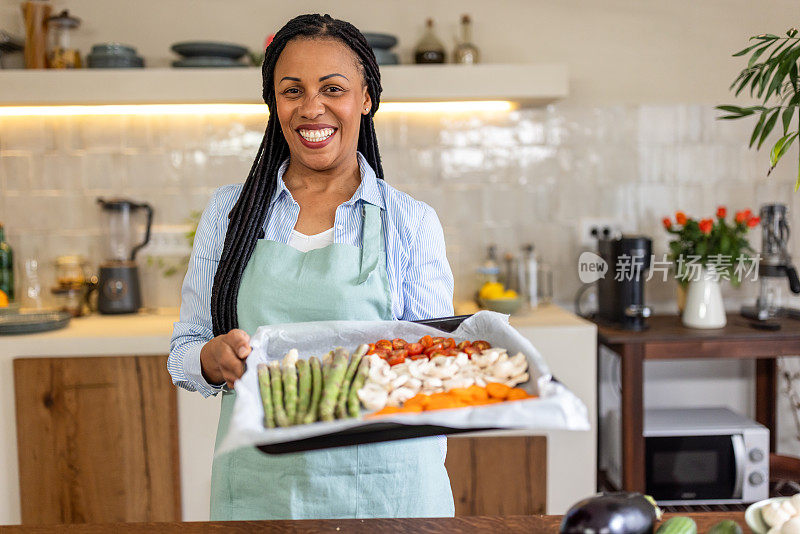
[258,315,497,454]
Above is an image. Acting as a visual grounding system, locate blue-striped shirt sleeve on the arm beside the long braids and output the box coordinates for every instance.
[167,191,222,397]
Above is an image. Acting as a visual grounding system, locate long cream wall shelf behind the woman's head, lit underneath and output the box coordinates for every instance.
[0,64,568,106]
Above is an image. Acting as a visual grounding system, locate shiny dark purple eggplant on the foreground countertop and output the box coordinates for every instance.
[559,491,661,534]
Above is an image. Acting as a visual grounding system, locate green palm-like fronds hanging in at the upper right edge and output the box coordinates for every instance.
[717,28,800,191]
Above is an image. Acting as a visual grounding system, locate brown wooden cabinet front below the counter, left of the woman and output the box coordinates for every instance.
[14,356,181,525]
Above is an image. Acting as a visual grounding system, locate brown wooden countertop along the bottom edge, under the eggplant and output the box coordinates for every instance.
[2,512,749,534]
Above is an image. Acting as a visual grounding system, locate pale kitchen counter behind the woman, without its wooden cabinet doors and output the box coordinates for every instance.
[0,305,596,525]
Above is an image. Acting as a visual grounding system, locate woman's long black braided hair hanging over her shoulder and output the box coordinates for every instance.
[211,14,383,336]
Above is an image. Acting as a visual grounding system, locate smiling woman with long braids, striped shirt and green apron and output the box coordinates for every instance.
[168,15,453,520]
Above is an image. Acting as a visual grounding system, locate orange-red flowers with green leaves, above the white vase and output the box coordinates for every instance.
[662,206,761,287]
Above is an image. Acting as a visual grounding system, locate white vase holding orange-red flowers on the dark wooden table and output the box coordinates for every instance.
[663,206,761,328]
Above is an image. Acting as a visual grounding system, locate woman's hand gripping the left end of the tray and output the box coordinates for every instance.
[200,328,253,388]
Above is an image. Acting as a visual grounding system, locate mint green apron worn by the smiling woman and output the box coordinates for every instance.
[211,201,454,520]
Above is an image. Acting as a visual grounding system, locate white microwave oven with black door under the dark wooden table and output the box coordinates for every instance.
[601,408,769,505]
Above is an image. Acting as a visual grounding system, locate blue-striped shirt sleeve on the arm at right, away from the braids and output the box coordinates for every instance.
[400,204,453,321]
